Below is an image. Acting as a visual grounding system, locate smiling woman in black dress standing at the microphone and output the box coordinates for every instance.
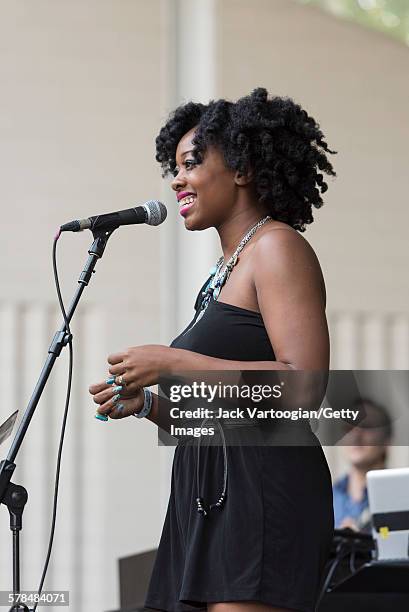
[90,88,335,612]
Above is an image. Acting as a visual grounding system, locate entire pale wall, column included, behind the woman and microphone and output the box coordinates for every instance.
[0,0,409,612]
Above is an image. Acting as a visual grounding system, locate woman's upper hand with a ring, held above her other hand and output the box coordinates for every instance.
[108,344,173,393]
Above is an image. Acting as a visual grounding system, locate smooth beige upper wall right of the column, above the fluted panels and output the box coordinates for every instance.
[217,0,409,313]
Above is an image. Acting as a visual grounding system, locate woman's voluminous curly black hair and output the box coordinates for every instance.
[156,87,336,232]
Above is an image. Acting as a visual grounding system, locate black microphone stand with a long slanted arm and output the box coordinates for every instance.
[0,225,119,612]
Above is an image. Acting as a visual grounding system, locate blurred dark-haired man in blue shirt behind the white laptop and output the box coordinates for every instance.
[333,398,393,532]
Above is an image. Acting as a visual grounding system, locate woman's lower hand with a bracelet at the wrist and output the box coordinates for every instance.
[88,381,145,419]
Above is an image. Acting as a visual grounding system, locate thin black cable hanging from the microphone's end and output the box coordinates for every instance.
[32,231,74,612]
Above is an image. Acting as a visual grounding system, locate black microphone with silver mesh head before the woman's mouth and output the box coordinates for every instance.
[60,200,168,232]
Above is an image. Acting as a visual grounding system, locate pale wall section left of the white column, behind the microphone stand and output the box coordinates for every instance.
[0,0,163,612]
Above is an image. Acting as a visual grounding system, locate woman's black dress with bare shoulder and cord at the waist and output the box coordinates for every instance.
[145,281,334,612]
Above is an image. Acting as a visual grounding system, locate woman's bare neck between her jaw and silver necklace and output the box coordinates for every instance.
[216,205,269,261]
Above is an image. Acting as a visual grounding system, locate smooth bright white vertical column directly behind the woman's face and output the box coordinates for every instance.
[158,0,220,514]
